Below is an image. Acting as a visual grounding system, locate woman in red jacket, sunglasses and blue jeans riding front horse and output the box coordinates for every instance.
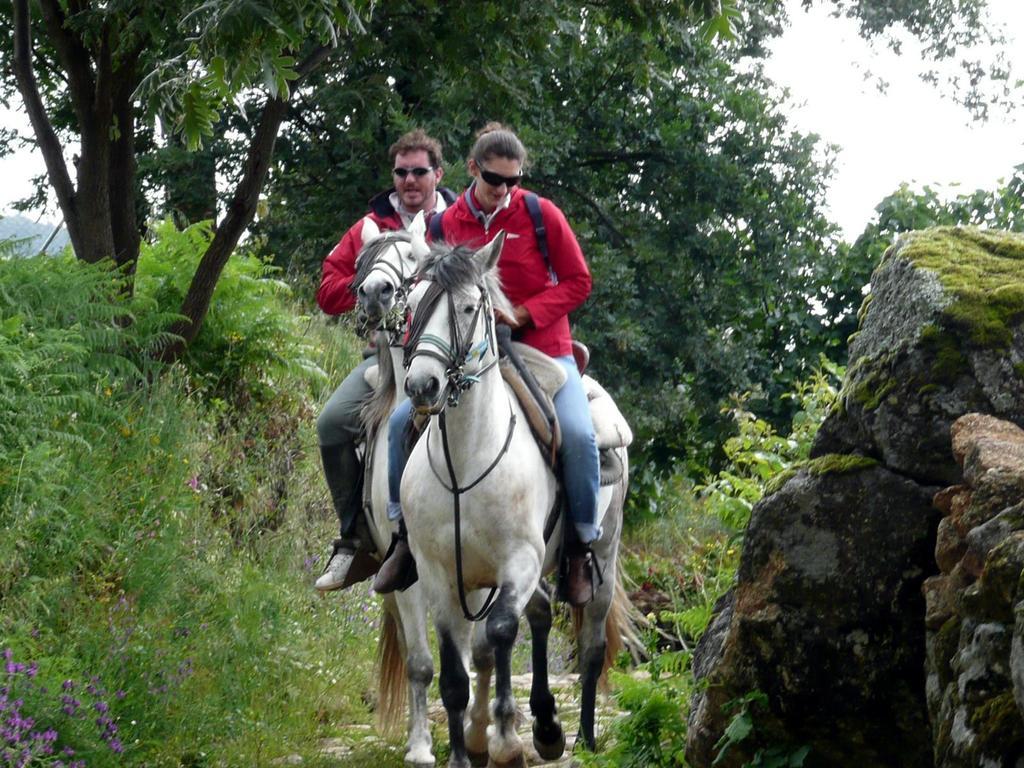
[374,123,601,605]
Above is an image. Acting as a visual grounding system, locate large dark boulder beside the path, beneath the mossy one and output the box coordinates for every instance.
[687,457,938,767]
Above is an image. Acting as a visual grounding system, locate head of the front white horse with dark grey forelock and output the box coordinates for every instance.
[404,231,511,413]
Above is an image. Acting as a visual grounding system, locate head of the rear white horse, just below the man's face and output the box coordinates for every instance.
[352,212,428,332]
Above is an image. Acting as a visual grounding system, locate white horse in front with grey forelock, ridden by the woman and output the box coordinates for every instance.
[401,233,629,768]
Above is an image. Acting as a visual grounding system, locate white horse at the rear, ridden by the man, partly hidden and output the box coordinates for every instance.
[353,214,434,768]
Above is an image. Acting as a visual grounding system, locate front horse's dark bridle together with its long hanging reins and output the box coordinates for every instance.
[402,282,516,622]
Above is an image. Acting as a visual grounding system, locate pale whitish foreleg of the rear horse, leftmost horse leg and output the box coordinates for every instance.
[394,588,434,768]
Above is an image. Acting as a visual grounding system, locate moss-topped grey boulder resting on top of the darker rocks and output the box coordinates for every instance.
[812,227,1024,484]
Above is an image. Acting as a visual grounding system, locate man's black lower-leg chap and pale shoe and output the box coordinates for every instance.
[314,442,378,592]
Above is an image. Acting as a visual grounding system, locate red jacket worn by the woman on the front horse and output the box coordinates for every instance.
[441,187,591,357]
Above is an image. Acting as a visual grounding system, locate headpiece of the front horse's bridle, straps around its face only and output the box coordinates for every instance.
[402,283,498,409]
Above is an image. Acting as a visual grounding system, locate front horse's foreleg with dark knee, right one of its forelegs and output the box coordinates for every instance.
[486,584,526,768]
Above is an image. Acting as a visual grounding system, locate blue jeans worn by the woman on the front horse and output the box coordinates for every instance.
[388,355,601,544]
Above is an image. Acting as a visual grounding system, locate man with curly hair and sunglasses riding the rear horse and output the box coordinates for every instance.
[315,130,455,593]
